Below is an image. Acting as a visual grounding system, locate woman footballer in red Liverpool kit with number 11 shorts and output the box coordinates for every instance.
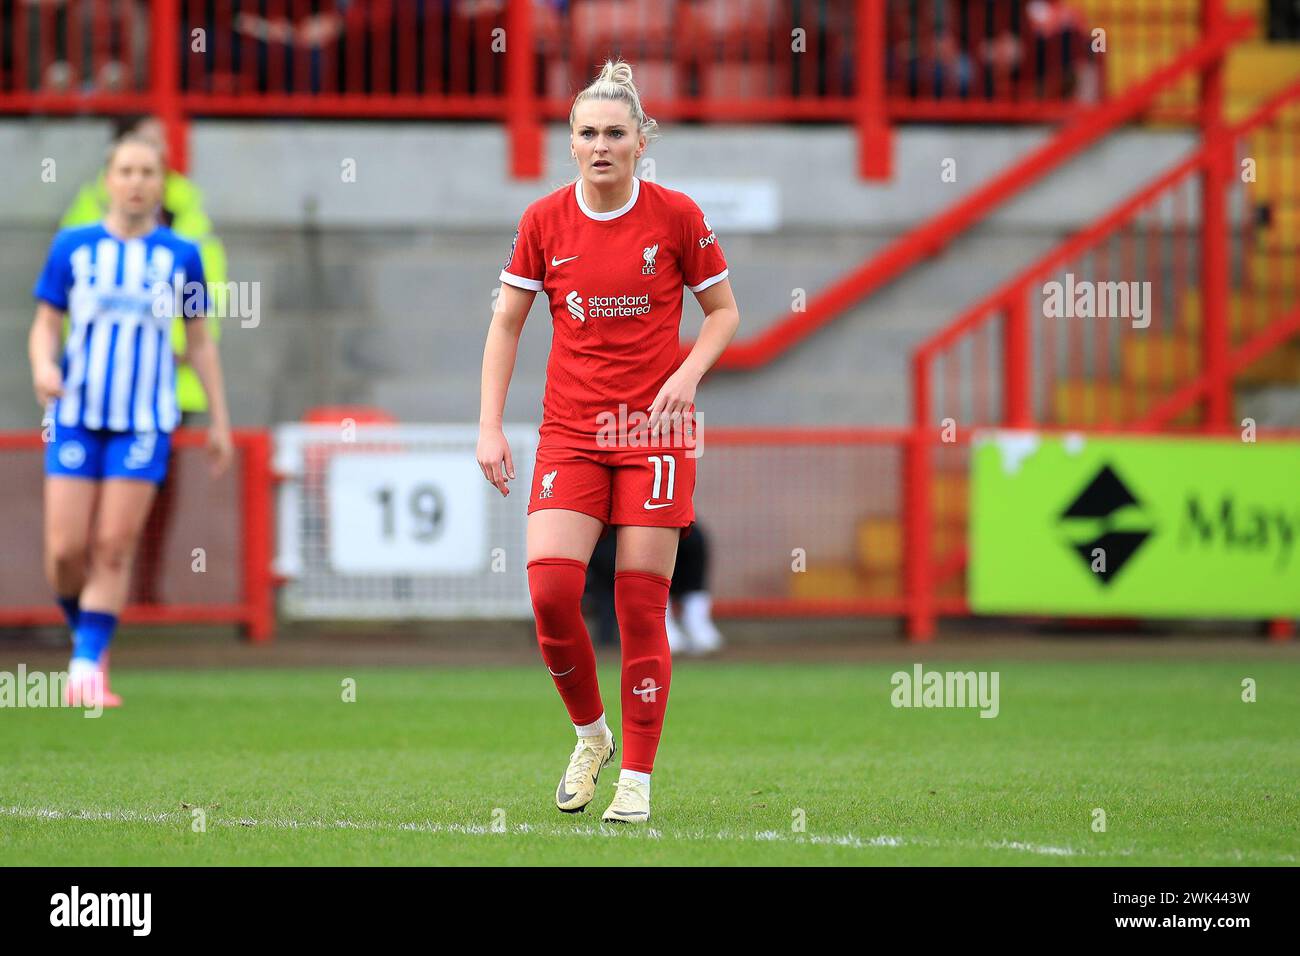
[477,61,740,822]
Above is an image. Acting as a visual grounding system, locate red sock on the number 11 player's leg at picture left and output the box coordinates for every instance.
[528,558,605,723]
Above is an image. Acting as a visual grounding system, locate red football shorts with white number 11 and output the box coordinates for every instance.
[528,445,696,536]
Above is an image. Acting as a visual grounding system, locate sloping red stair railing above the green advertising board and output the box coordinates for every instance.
[906,83,1300,637]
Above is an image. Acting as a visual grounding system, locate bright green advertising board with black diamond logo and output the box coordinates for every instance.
[969,431,1300,618]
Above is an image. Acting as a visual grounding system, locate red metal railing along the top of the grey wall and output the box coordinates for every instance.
[0,0,1200,177]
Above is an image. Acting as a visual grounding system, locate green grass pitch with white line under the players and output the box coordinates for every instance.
[0,661,1300,865]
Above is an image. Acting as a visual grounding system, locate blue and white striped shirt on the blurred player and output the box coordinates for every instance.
[33,222,208,432]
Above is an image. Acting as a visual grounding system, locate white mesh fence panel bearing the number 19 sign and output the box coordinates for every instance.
[274,423,537,620]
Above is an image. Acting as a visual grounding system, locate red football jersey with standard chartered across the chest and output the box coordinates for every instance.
[501,178,727,447]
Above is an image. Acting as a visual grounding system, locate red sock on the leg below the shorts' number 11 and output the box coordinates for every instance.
[614,571,672,774]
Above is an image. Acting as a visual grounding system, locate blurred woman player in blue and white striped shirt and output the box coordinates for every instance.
[29,137,231,706]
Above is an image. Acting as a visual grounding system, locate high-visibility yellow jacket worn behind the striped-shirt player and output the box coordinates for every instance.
[59,172,226,412]
